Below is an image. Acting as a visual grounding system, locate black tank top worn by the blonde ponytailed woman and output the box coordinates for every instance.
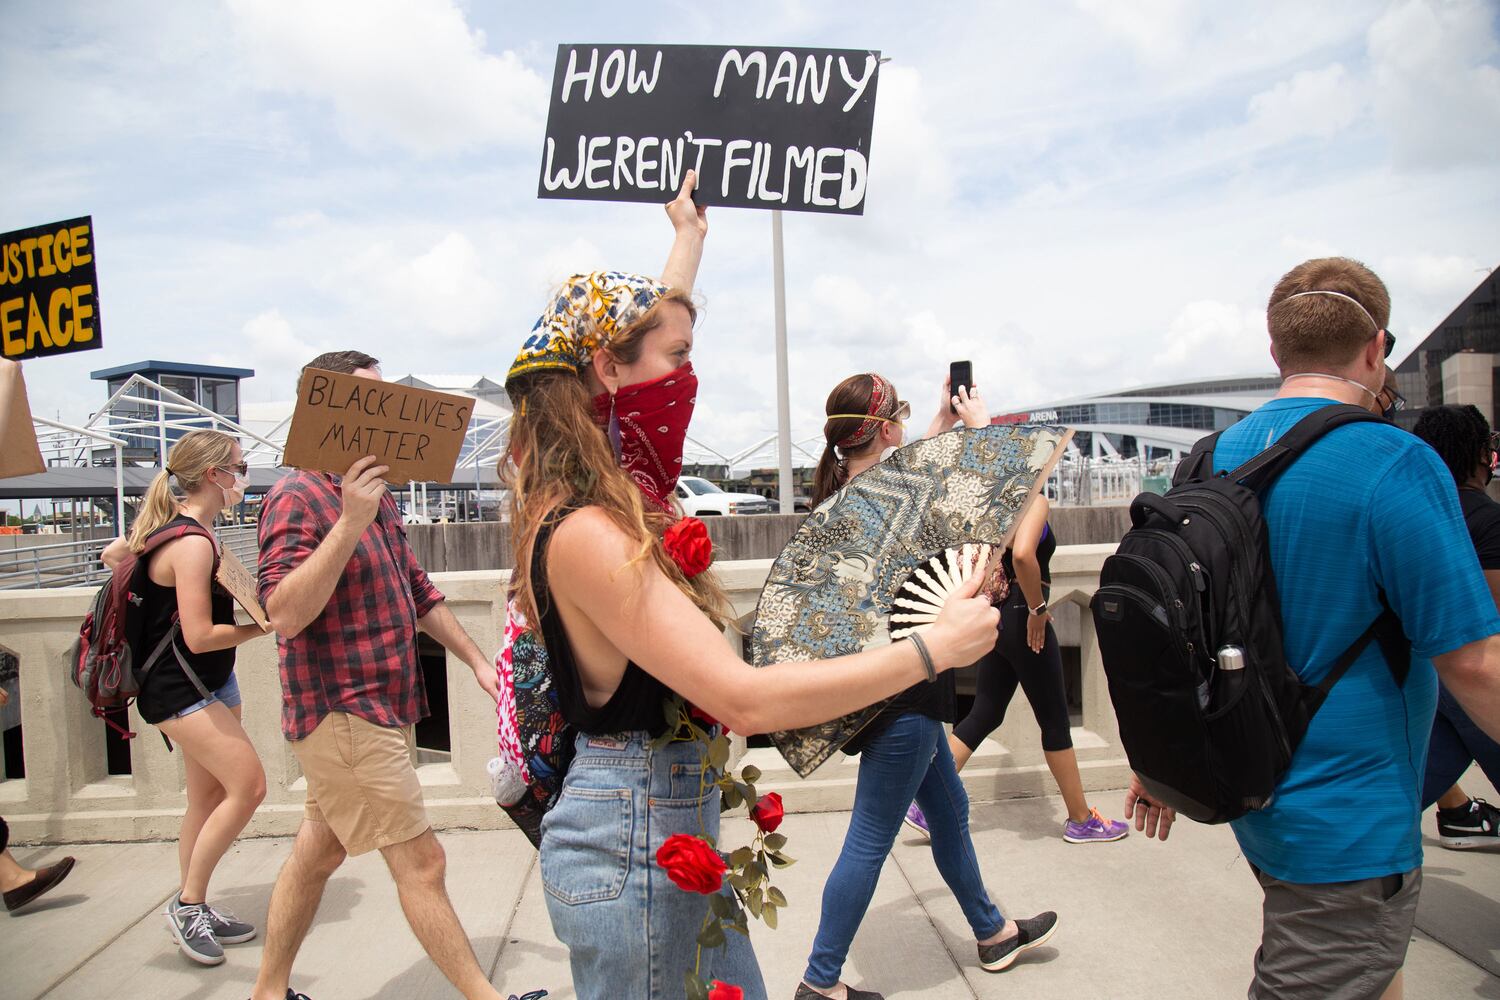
[135,514,234,726]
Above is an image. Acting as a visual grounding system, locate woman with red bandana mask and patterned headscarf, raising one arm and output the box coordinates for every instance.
[504,171,996,1000]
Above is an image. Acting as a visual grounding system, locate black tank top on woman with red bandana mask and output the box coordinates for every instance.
[531,507,672,736]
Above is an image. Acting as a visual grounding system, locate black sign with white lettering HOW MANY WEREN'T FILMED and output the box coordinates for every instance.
[537,45,881,216]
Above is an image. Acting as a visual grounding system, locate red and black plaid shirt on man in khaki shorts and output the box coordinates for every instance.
[260,472,443,739]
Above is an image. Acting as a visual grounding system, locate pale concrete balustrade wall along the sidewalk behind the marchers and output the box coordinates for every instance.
[0,554,1127,843]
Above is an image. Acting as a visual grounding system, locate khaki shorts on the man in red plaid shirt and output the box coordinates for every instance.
[291,712,432,858]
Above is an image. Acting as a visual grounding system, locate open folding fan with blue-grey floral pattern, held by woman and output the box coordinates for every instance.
[752,424,1073,778]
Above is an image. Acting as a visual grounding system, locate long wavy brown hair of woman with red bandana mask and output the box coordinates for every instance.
[500,289,734,628]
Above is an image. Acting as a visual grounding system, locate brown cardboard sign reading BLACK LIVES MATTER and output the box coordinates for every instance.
[282,369,474,483]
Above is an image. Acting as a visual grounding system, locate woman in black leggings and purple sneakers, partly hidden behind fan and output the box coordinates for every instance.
[906,495,1130,844]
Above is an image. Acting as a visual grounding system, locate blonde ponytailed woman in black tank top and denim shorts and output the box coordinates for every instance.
[102,430,266,966]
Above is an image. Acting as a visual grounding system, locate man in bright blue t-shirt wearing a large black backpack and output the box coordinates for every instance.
[1127,258,1500,1000]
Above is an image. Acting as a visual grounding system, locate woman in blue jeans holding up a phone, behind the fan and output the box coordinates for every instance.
[797,373,1058,1000]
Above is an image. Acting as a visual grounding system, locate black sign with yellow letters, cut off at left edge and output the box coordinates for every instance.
[0,216,104,361]
